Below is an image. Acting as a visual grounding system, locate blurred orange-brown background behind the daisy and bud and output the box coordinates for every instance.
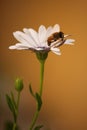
[0,0,87,130]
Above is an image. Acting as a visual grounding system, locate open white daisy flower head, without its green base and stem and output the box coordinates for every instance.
[9,24,75,55]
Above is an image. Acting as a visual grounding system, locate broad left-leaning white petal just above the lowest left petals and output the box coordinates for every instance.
[13,31,36,47]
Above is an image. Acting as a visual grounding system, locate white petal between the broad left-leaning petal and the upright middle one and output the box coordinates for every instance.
[23,28,39,45]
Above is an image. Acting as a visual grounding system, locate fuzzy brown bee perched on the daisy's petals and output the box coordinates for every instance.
[47,32,64,46]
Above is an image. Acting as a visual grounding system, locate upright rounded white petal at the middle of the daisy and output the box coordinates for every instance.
[38,25,47,45]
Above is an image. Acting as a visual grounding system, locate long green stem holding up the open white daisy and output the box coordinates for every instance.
[29,60,45,130]
